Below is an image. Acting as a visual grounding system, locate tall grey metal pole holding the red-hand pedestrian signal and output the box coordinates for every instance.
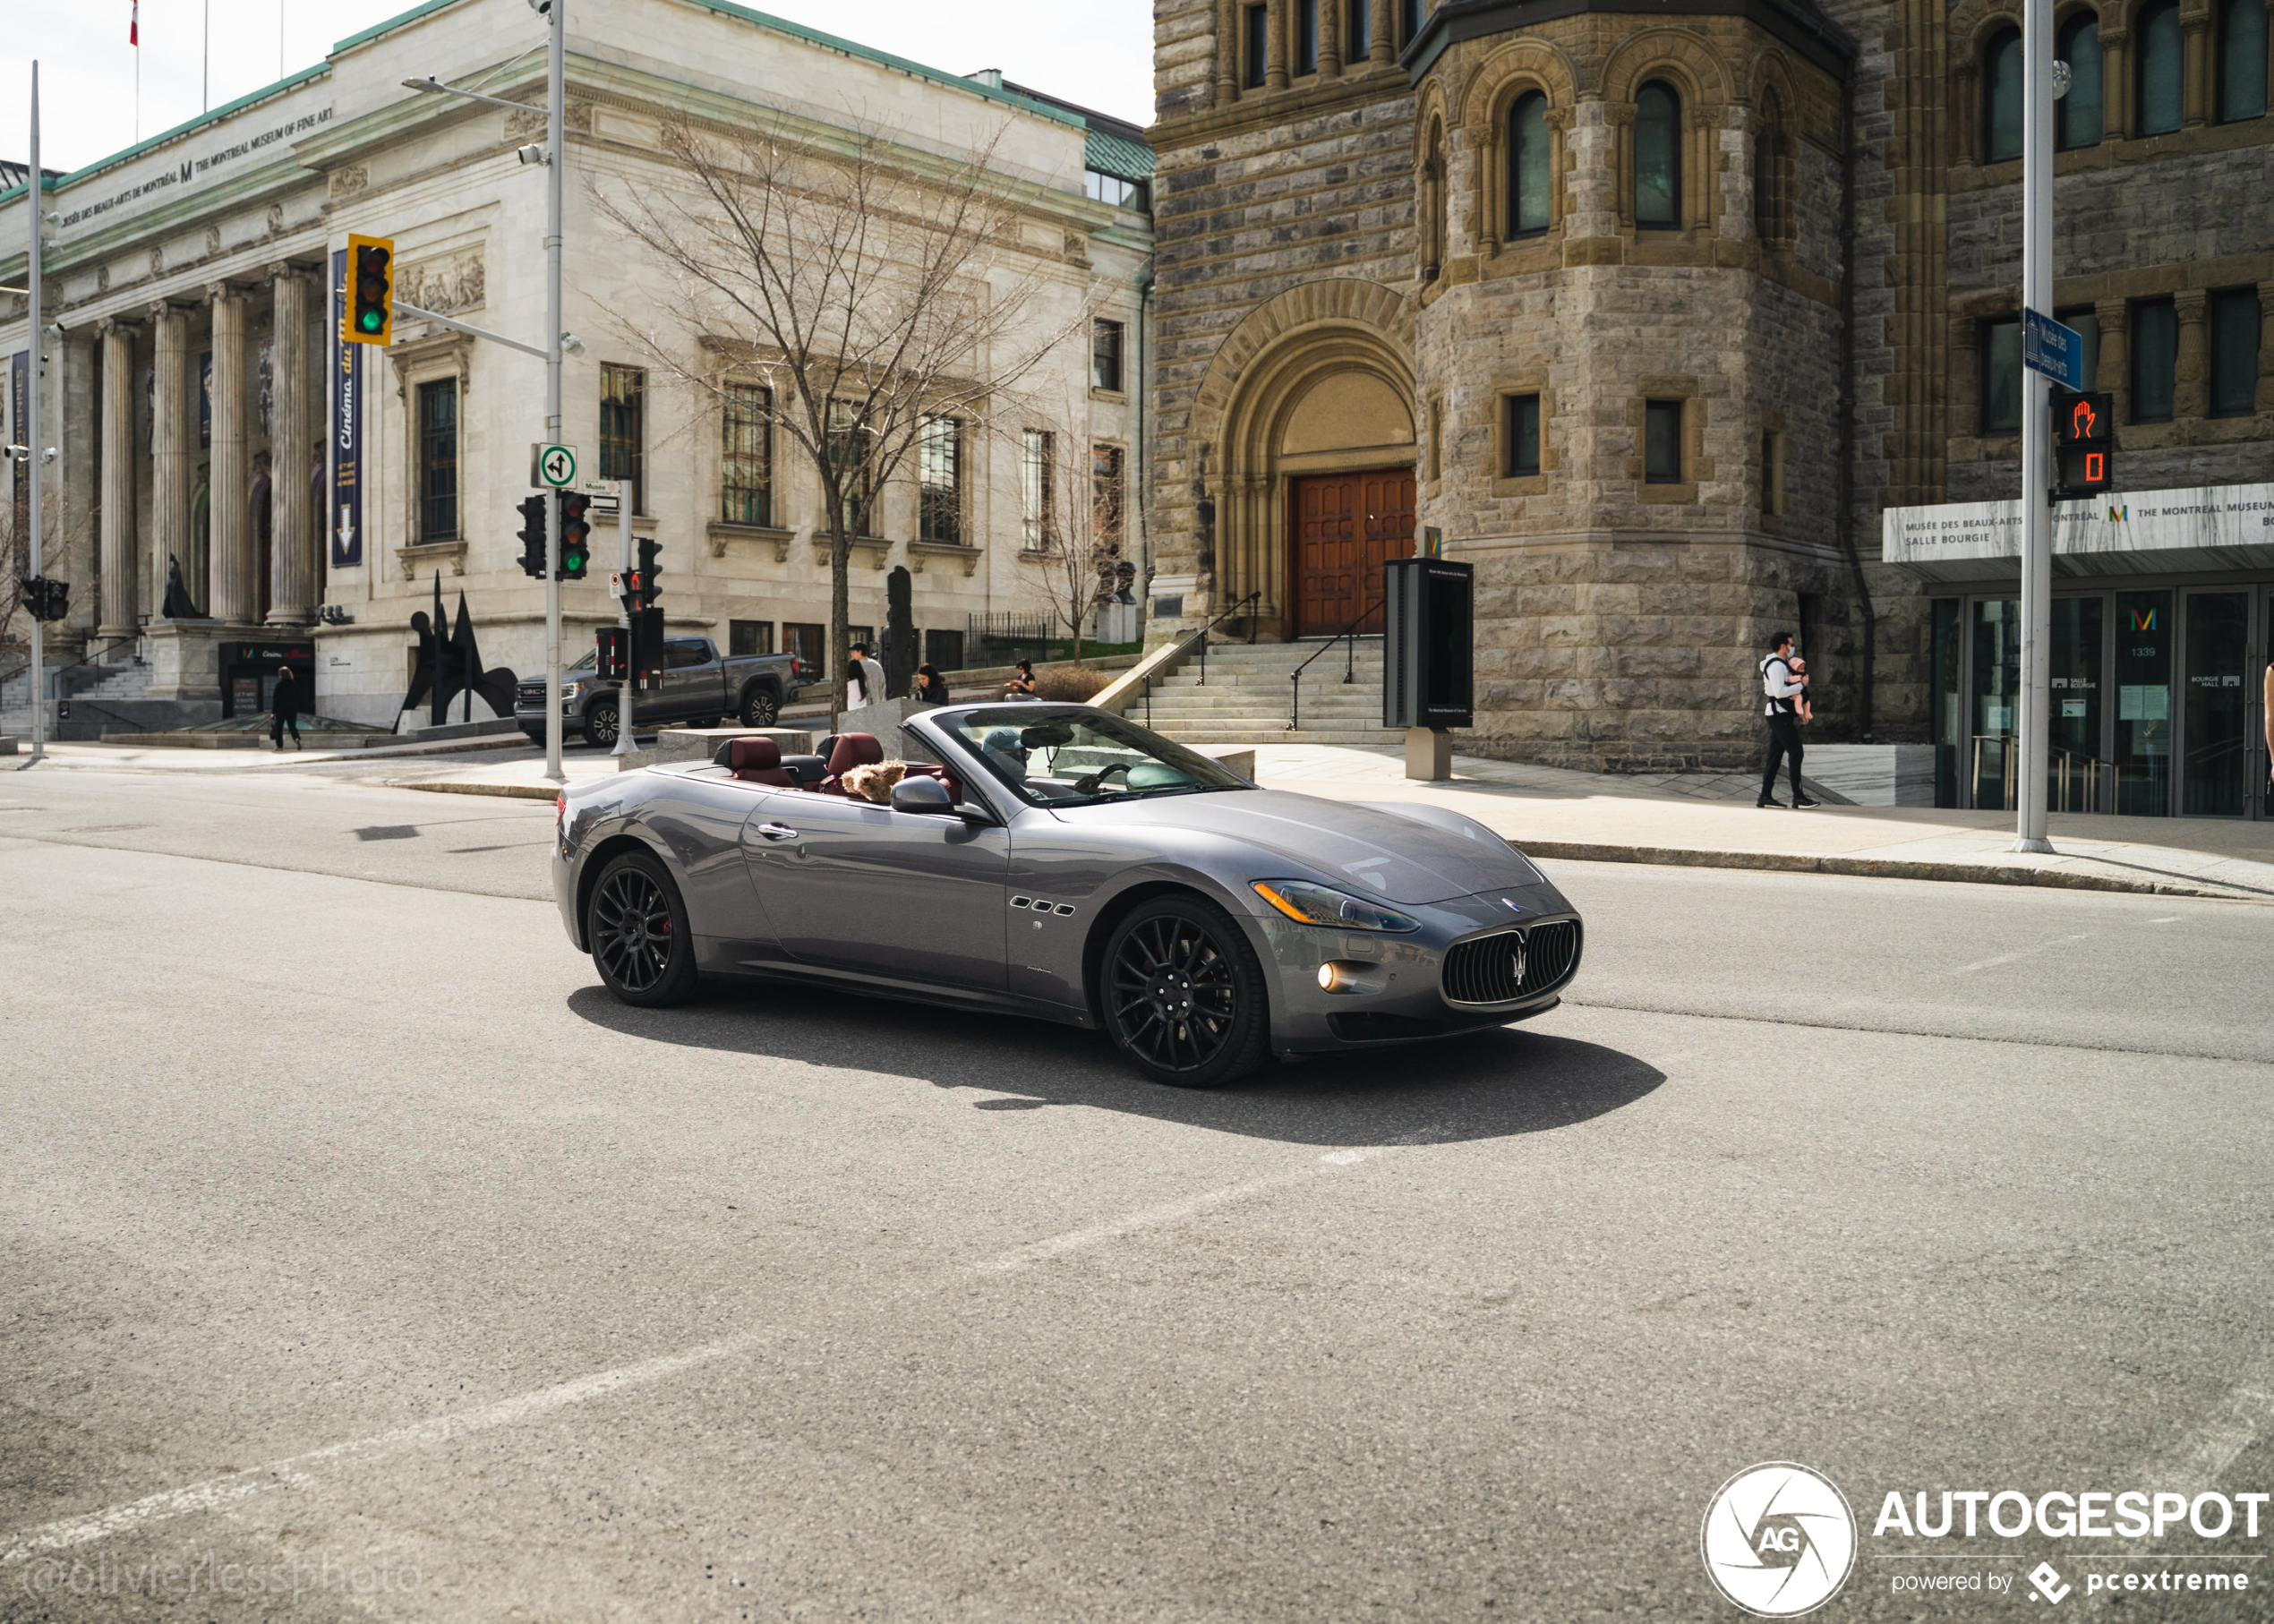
[2013,0,2054,850]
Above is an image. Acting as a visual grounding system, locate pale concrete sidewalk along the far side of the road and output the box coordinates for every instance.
[372,744,2274,903]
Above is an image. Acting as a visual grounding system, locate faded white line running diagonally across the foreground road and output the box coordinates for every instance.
[0,1133,1435,1567]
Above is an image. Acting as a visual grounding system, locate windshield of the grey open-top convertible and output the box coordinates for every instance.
[942,705,1248,808]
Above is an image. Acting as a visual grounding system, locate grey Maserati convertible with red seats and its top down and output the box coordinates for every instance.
[552,703,1580,1087]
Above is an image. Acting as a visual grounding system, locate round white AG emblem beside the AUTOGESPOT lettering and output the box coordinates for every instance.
[1698,1460,1856,1620]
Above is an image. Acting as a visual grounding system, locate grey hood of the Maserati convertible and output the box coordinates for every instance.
[1057,790,1540,905]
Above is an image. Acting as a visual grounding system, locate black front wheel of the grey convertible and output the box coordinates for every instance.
[1099,896,1271,1087]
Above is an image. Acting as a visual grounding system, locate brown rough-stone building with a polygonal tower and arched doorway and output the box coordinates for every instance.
[1150,0,2274,815]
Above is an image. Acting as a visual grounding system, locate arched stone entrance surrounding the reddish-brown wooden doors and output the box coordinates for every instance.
[1194,278,1415,637]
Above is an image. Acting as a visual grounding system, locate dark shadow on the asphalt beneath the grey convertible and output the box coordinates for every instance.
[568,987,1667,1146]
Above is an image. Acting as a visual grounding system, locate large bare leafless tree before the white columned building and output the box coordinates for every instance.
[594,118,1091,725]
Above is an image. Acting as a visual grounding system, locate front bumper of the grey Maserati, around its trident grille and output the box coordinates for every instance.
[1260,883,1585,1056]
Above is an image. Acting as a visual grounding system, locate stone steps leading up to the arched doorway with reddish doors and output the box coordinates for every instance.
[1121,637,1406,744]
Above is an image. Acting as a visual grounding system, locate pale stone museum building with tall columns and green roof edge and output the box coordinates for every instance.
[0,0,1150,737]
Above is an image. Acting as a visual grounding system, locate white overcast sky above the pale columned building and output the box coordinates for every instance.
[0,0,1153,173]
